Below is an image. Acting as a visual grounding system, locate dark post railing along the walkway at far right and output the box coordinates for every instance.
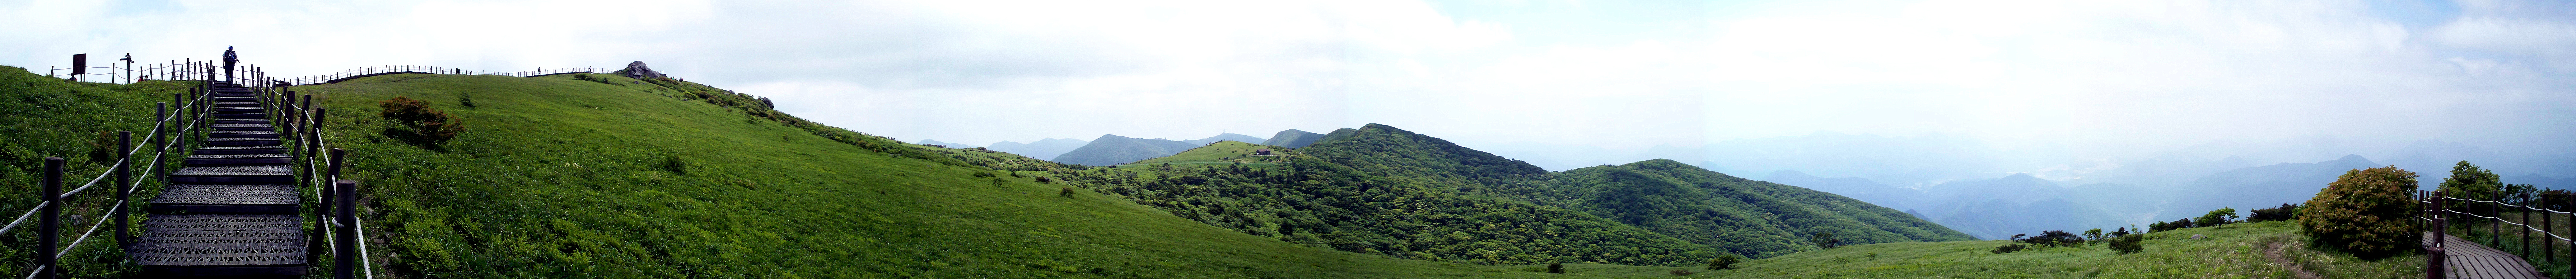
[2416,191,2576,279]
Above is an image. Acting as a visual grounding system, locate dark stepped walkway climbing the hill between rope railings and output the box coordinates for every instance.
[126,83,312,279]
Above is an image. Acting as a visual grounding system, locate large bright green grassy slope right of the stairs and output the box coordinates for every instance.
[296,75,1731,279]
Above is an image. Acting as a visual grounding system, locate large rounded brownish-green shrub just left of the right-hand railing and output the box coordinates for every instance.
[2298,163,2421,258]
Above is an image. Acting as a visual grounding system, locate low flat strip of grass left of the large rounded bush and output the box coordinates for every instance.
[1708,222,2424,279]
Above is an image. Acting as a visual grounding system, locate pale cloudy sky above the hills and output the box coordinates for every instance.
[0,0,2576,178]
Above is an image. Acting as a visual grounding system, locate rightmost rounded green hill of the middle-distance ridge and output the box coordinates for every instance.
[1491,160,1973,258]
